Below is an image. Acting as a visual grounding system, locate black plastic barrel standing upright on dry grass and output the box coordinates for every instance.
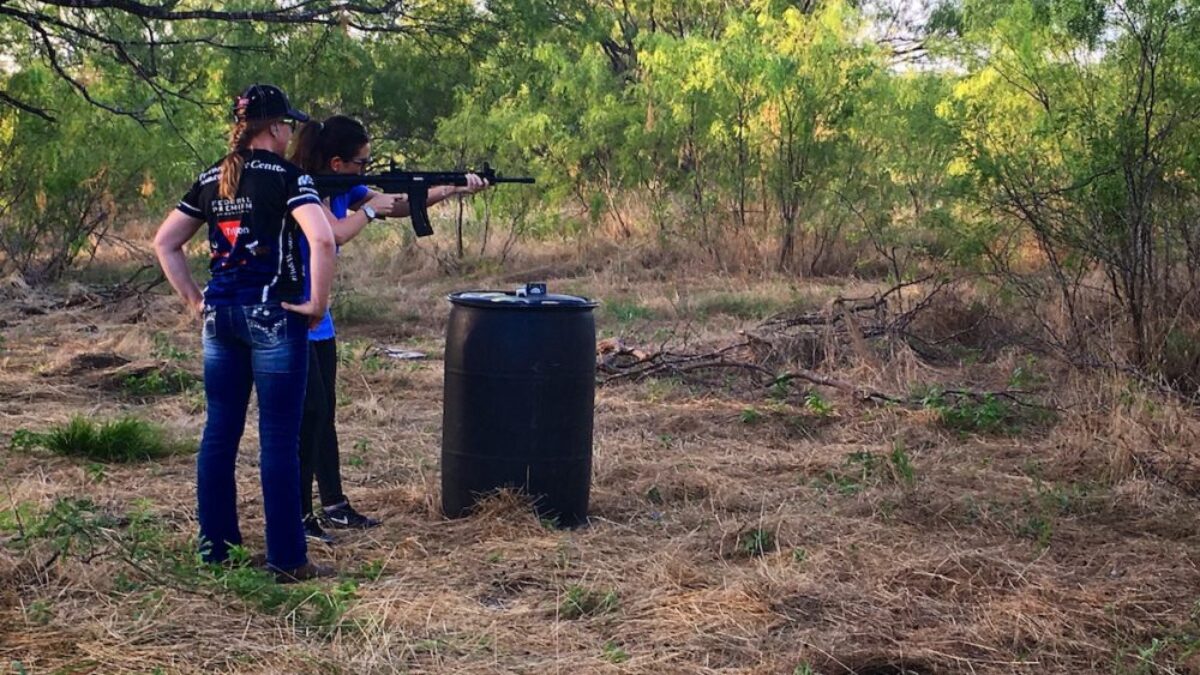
[442,283,596,527]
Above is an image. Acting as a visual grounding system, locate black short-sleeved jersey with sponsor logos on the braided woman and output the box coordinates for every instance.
[176,150,320,305]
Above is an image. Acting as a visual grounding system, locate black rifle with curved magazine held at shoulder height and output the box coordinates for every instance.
[312,162,534,237]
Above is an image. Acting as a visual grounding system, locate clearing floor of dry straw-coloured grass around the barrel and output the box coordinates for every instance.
[0,239,1200,674]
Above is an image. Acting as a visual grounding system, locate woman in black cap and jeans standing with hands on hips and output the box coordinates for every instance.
[155,84,334,581]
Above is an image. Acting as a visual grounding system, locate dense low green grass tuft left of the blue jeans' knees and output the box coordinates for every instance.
[10,417,191,464]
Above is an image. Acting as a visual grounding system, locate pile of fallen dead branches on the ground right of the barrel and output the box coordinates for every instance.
[598,276,1046,420]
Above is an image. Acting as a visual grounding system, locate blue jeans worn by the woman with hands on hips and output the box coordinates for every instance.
[196,303,308,569]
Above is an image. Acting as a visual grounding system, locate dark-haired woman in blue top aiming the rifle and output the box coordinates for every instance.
[292,115,487,544]
